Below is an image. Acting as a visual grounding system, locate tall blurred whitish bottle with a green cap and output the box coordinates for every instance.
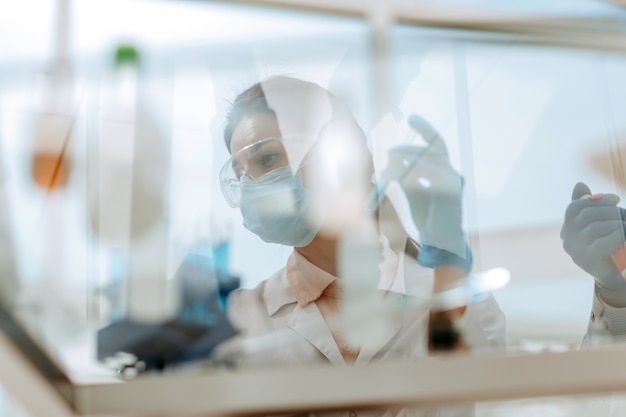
[91,44,180,323]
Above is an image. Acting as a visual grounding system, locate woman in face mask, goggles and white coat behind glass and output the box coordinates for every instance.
[212,76,505,415]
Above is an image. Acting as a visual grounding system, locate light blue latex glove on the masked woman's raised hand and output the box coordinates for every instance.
[381,115,471,271]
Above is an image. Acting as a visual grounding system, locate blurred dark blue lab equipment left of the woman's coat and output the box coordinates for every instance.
[97,253,239,377]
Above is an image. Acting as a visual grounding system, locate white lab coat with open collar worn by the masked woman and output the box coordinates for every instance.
[218,197,505,417]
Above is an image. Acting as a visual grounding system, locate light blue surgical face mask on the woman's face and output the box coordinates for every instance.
[240,165,320,246]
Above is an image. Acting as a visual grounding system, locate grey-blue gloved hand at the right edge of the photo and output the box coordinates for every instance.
[561,182,626,305]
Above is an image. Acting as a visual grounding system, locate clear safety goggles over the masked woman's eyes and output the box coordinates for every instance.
[220,137,309,207]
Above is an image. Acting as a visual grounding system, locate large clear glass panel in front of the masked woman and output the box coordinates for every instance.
[0,1,626,415]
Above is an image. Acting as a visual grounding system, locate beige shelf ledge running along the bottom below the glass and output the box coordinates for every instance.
[0,316,626,417]
